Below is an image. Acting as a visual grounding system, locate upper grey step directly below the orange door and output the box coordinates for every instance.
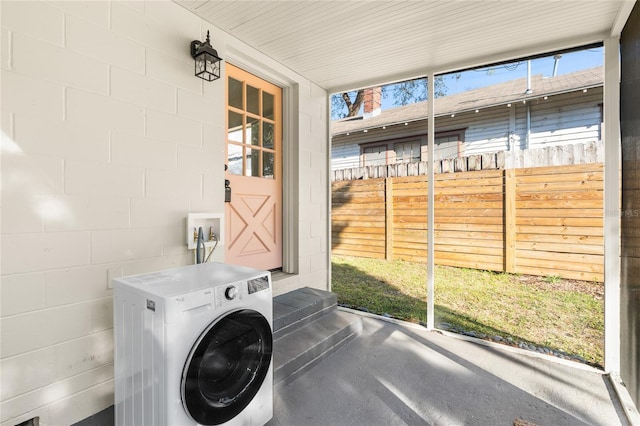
[273,287,338,340]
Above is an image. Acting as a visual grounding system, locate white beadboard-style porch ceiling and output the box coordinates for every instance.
[174,0,635,92]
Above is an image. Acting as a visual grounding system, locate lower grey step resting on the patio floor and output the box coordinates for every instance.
[273,309,362,387]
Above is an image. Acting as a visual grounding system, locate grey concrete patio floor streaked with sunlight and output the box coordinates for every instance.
[269,315,629,426]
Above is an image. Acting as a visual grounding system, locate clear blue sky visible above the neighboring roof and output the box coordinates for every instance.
[332,47,604,119]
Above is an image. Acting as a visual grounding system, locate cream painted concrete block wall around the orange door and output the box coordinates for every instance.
[0,0,328,426]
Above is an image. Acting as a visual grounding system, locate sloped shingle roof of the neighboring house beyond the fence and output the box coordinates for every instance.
[331,67,604,135]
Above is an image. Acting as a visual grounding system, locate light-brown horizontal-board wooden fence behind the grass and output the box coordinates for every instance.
[332,163,604,281]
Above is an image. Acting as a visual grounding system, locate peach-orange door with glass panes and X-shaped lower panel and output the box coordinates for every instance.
[225,63,282,269]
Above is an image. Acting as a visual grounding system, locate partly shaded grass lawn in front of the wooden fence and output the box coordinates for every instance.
[332,256,604,366]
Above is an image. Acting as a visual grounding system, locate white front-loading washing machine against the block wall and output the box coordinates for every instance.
[113,262,273,426]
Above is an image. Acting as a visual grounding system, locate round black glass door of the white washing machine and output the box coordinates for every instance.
[181,309,273,425]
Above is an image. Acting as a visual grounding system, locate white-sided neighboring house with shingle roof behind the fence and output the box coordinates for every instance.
[331,67,603,170]
